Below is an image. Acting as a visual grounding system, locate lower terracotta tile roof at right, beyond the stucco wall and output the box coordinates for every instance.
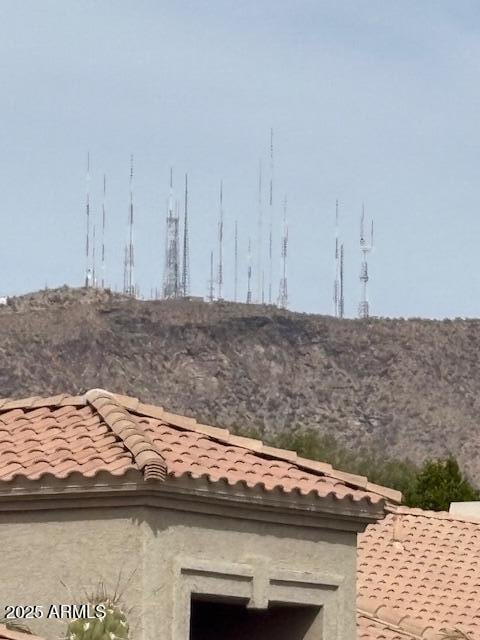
[357,507,480,640]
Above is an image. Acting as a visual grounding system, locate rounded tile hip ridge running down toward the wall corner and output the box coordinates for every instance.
[85,389,167,480]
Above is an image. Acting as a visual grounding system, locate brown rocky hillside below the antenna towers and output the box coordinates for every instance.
[0,289,480,483]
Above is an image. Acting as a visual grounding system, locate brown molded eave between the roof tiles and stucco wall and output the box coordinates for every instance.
[0,470,386,533]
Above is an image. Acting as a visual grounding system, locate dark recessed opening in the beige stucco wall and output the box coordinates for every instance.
[190,597,321,640]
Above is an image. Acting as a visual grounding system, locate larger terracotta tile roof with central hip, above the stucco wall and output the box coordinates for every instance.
[0,389,401,504]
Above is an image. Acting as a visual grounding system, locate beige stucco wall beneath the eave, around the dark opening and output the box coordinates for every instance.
[0,507,356,640]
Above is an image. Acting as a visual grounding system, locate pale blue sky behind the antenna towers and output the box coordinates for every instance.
[0,0,480,318]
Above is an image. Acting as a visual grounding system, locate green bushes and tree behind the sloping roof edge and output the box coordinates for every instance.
[253,429,480,511]
